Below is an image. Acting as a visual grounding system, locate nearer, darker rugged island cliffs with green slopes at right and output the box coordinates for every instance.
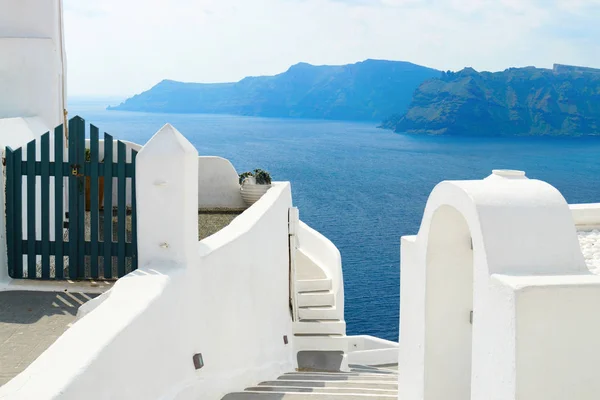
[382,64,600,136]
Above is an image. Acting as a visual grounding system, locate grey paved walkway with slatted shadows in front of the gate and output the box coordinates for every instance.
[0,290,98,386]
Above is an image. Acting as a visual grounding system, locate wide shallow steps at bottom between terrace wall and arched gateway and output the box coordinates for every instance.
[222,365,398,400]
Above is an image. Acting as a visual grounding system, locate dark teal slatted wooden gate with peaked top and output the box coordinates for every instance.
[6,117,137,280]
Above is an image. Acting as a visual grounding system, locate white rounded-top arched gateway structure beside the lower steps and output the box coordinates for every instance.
[399,171,600,400]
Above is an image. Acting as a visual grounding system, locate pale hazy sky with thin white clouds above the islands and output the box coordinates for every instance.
[63,0,600,96]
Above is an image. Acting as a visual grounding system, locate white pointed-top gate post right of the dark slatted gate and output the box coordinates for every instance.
[136,124,198,268]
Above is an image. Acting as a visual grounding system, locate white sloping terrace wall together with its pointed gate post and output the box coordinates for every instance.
[0,126,293,400]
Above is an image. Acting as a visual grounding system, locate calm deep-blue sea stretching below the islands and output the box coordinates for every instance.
[69,102,600,340]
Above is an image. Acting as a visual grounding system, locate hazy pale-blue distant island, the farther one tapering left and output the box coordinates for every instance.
[108,60,441,122]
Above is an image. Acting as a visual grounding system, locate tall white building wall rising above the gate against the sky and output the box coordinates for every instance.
[0,0,66,139]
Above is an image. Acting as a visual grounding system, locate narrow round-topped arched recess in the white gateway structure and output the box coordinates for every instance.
[425,206,473,400]
